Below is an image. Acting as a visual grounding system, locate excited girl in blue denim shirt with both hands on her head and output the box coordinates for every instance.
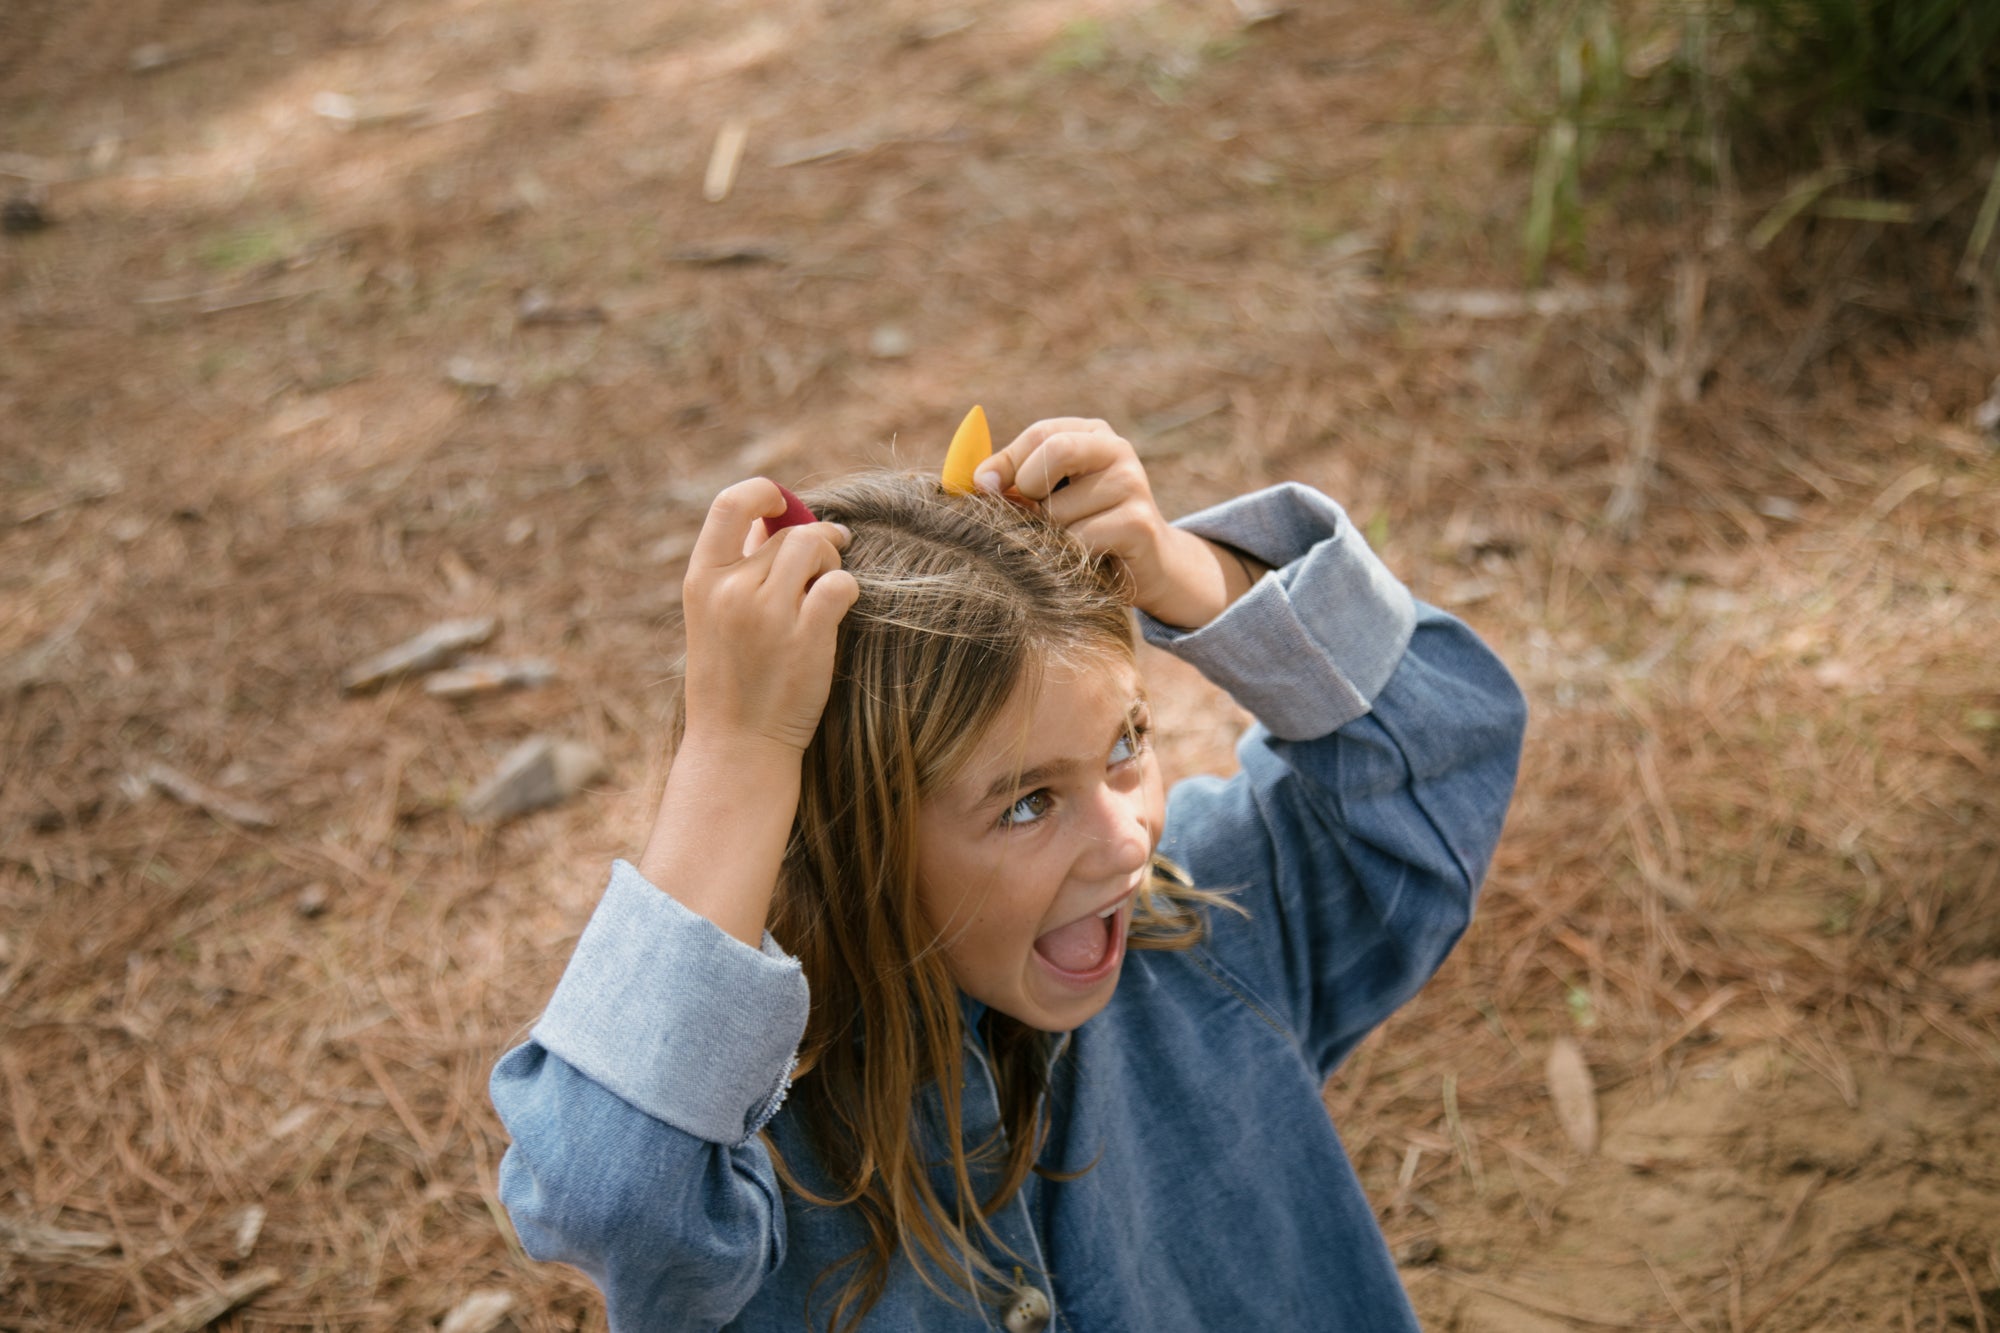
[492,418,1524,1333]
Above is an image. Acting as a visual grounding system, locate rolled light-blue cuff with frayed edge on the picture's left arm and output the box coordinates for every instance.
[534,861,808,1147]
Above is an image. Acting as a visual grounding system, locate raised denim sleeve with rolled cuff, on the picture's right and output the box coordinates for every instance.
[1142,484,1526,1075]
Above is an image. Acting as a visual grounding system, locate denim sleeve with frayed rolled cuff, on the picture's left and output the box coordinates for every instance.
[490,861,808,1329]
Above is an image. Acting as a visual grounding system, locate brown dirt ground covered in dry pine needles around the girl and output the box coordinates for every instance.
[0,0,2000,1333]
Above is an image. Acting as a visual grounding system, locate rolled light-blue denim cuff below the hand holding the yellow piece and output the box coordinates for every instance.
[1140,482,1416,741]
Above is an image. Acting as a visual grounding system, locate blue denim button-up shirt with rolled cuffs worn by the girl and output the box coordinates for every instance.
[492,484,1524,1333]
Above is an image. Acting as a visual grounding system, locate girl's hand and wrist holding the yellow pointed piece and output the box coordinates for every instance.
[974,416,1252,628]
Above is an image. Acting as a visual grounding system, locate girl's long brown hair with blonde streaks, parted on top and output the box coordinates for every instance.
[732,472,1216,1329]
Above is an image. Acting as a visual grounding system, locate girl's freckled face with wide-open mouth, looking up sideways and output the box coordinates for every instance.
[916,656,1166,1033]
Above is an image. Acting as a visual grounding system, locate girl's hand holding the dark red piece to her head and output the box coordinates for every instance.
[680,476,860,755]
